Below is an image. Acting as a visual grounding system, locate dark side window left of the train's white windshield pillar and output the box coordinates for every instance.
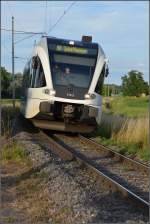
[30,57,46,88]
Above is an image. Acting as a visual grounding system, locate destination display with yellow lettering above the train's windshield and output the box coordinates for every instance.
[49,44,97,55]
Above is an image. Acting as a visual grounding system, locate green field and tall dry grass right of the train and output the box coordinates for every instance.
[91,96,149,161]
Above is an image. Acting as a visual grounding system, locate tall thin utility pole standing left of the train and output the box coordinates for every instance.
[12,16,15,108]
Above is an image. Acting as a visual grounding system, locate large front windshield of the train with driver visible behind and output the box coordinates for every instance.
[50,43,97,88]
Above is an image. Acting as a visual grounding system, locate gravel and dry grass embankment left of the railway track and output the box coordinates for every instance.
[0,105,148,223]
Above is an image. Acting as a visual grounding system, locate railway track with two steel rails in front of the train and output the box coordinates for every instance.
[40,133,149,212]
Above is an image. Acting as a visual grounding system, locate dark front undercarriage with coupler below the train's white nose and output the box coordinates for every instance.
[31,102,98,133]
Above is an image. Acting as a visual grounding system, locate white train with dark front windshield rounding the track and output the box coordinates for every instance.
[21,36,108,133]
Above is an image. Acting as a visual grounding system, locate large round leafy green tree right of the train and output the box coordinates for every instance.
[121,70,149,96]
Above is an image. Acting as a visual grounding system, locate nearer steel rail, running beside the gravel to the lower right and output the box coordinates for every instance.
[41,134,150,212]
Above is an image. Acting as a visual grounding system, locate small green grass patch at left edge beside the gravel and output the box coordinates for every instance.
[1,141,29,164]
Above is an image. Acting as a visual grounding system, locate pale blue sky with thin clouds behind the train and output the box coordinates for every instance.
[1,1,149,85]
